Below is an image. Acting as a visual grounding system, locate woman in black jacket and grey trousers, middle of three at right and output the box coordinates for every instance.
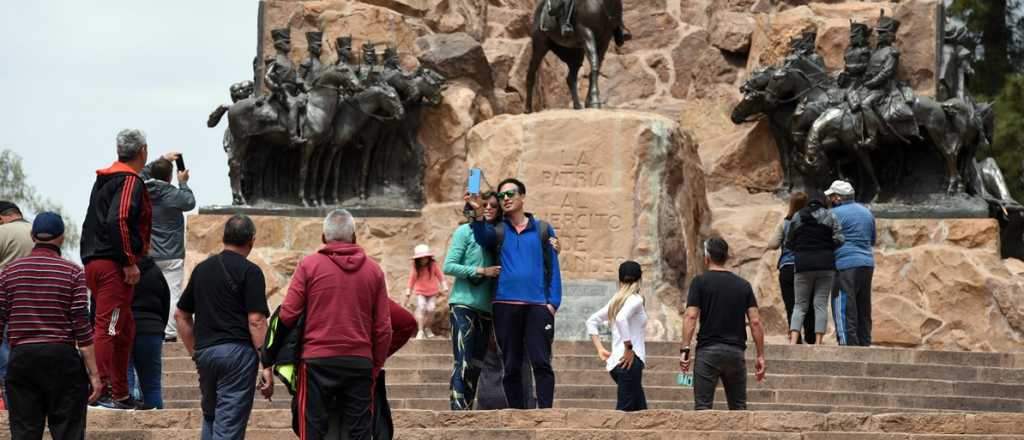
[784,200,845,344]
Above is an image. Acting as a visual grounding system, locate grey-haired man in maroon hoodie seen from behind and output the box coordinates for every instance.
[281,210,392,440]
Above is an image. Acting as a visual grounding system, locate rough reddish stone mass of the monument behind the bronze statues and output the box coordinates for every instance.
[186,0,1024,351]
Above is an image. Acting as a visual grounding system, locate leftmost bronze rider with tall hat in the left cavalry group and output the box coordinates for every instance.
[257,28,304,143]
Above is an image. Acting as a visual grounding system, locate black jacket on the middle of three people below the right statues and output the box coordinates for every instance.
[785,201,845,273]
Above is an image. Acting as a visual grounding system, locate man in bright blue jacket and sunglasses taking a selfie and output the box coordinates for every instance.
[469,178,562,409]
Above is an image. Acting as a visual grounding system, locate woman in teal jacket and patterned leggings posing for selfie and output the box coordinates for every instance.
[443,192,502,410]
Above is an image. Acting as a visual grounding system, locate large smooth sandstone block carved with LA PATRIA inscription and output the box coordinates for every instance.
[466,111,707,338]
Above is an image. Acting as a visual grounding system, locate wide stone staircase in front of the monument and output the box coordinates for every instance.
[8,340,1024,440]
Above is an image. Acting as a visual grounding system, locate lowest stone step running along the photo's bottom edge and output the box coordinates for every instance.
[0,409,1024,440]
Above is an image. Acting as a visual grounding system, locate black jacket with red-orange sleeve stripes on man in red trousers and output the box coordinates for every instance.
[81,162,153,266]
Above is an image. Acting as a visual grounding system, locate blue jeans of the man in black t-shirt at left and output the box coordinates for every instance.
[193,343,259,440]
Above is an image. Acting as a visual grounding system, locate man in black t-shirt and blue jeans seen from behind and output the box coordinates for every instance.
[174,215,273,439]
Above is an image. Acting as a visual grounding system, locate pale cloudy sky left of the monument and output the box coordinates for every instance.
[0,0,257,224]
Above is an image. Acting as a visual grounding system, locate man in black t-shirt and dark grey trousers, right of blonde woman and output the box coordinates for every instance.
[679,236,765,410]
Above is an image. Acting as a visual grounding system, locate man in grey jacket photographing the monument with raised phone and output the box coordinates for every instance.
[142,152,196,342]
